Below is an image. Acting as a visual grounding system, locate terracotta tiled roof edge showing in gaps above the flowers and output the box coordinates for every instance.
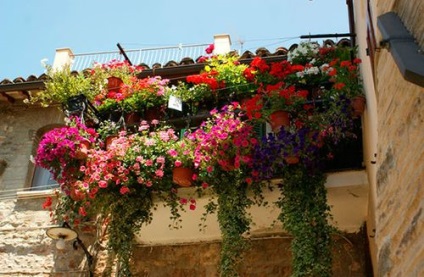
[0,39,350,104]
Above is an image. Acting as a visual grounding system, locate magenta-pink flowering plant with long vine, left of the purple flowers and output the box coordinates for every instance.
[188,103,257,276]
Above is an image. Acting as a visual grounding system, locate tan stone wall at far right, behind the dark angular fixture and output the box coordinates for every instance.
[375,0,424,276]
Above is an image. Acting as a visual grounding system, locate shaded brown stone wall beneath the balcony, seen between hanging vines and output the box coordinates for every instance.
[130,233,371,277]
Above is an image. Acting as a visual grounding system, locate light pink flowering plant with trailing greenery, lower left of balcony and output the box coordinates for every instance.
[47,121,185,276]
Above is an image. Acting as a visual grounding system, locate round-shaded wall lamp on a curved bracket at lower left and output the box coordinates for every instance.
[46,222,94,277]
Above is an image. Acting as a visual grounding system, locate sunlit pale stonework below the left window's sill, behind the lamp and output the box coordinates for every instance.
[0,197,93,277]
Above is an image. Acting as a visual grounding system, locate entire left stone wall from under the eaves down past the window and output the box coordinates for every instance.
[0,104,90,276]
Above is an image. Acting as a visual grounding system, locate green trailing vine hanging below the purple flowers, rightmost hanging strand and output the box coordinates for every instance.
[277,165,334,277]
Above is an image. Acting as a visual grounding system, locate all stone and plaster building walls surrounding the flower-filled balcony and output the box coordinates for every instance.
[0,0,424,276]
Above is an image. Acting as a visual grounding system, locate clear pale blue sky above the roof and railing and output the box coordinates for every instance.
[0,0,349,80]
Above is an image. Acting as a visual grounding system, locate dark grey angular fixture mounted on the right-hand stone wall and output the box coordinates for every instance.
[377,12,424,87]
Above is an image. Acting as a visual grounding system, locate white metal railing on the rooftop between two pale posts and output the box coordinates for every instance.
[72,44,208,71]
